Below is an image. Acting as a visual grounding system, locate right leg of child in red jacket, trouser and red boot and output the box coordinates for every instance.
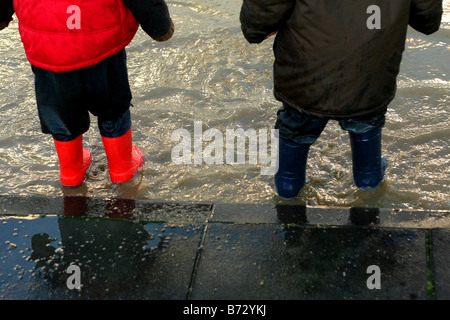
[85,50,144,183]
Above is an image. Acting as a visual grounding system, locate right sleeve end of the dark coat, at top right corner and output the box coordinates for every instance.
[409,0,443,35]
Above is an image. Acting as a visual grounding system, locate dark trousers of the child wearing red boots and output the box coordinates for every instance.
[32,49,132,141]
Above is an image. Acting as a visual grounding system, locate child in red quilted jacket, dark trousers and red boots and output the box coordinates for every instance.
[0,0,174,187]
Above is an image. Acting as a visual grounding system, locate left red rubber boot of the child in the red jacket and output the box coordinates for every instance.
[53,135,92,187]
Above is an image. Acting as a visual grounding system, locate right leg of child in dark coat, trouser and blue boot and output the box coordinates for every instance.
[339,113,386,189]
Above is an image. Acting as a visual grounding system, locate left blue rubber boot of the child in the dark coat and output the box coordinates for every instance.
[275,138,310,199]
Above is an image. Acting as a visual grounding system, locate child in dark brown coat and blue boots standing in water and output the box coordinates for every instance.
[240,0,442,198]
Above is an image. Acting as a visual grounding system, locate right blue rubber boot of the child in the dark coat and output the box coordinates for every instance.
[350,128,386,189]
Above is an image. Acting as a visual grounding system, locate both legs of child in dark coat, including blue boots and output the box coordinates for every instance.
[275,106,386,198]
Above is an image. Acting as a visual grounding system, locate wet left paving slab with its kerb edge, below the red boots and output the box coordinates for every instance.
[0,197,211,300]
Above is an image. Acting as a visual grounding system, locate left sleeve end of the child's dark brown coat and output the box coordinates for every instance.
[239,0,295,43]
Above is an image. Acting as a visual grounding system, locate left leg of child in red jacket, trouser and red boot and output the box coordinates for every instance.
[33,67,92,187]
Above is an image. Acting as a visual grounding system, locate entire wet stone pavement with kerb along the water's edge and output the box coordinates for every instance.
[0,197,450,301]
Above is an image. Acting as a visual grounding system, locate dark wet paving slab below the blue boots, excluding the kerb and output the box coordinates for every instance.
[192,224,427,300]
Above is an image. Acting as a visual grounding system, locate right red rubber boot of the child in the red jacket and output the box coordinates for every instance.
[102,128,144,183]
